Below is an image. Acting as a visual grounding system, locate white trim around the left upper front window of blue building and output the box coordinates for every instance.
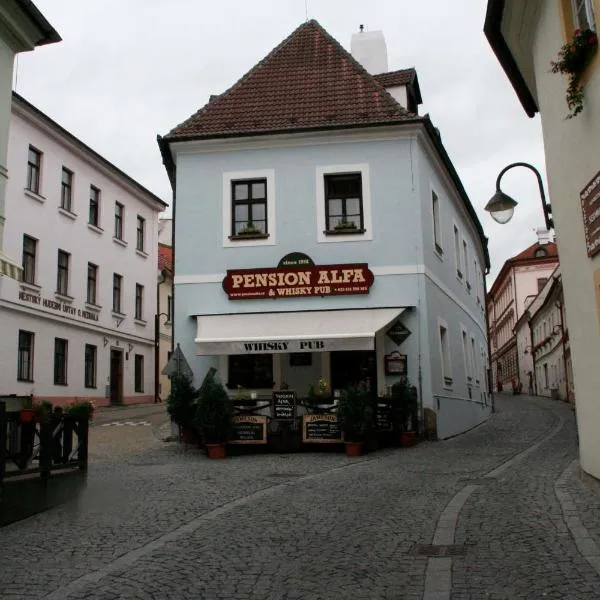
[222,169,277,248]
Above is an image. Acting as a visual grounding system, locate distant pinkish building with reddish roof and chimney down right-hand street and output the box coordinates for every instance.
[487,230,558,392]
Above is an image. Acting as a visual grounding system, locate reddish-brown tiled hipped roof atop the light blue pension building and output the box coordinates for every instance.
[165,20,419,140]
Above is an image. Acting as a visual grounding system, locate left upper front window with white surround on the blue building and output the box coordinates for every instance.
[222,169,276,247]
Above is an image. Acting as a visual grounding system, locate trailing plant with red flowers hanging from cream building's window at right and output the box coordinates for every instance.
[550,29,598,119]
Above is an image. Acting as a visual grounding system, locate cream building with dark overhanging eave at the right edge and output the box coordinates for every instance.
[484,0,600,478]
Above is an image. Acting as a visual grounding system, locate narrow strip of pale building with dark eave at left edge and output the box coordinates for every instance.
[0,0,60,279]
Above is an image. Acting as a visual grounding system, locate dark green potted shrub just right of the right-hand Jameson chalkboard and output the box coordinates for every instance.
[338,386,373,456]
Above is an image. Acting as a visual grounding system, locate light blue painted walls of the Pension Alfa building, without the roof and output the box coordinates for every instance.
[171,127,490,437]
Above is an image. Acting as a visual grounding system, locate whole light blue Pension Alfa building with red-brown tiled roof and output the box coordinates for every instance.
[159,21,491,438]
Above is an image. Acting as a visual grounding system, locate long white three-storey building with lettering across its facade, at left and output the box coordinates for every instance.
[0,94,165,405]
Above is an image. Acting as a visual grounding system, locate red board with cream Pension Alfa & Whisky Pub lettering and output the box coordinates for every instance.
[223,263,374,300]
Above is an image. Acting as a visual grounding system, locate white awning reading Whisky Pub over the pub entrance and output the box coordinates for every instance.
[196,308,404,356]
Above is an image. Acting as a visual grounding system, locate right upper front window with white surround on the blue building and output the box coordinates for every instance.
[316,164,373,243]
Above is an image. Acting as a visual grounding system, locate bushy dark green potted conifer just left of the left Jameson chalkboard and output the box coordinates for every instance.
[194,373,233,458]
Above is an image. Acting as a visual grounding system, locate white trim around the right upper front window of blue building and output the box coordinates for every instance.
[315,163,373,243]
